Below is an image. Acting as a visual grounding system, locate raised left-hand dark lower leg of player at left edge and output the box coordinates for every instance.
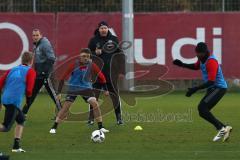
[0,105,18,132]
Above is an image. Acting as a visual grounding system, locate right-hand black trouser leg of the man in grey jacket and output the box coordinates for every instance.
[44,79,61,111]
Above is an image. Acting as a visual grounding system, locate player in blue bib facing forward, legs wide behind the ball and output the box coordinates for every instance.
[50,48,109,134]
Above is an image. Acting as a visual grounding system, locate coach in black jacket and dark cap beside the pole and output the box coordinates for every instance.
[88,21,125,125]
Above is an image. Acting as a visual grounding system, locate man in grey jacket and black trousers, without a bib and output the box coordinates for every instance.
[23,29,61,116]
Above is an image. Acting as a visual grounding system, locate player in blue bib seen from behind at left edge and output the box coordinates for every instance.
[0,52,36,152]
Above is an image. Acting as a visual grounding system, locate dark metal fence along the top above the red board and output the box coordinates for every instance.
[0,0,240,12]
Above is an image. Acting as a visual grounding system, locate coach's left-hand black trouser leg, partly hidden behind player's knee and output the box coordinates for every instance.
[87,83,102,125]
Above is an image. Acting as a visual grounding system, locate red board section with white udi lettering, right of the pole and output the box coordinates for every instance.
[135,13,240,79]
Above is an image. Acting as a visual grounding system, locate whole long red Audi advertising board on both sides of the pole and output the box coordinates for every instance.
[0,13,240,79]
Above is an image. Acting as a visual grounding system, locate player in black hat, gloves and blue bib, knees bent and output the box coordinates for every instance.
[173,42,232,142]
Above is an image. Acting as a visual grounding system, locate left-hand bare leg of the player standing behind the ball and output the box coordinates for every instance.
[50,95,77,134]
